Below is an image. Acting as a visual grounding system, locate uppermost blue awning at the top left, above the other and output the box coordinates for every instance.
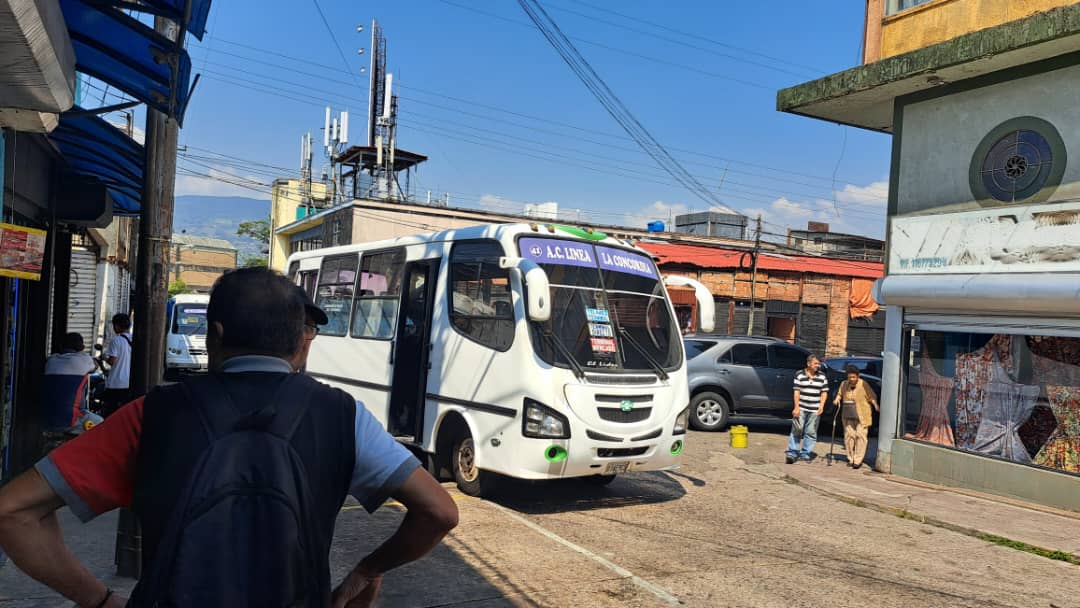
[60,0,194,124]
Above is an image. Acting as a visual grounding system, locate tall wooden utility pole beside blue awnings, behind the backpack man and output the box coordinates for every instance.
[116,13,184,579]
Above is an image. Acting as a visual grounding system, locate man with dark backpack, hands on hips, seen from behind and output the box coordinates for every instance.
[0,268,458,608]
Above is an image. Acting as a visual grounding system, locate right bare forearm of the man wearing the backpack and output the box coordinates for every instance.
[333,469,458,608]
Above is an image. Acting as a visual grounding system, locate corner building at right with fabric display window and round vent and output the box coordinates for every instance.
[778,0,1080,511]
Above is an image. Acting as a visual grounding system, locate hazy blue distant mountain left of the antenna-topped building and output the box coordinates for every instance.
[173,195,270,257]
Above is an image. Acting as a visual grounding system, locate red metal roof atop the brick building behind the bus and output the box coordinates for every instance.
[637,243,885,279]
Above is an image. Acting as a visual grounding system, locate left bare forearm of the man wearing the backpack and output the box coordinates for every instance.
[0,469,119,606]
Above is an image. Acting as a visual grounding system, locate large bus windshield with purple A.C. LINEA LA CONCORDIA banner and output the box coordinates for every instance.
[518,238,681,371]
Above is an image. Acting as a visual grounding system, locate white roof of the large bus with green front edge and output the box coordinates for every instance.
[288,222,651,264]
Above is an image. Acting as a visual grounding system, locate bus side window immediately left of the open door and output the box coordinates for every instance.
[352,249,405,340]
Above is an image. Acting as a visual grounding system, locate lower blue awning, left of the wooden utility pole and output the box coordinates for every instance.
[49,108,145,215]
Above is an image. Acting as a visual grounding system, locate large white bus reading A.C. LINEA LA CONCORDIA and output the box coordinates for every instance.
[288,225,713,496]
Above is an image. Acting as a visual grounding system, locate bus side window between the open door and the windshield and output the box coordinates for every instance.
[450,242,514,351]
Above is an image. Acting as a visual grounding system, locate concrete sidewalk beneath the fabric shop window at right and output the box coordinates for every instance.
[723,421,1080,558]
